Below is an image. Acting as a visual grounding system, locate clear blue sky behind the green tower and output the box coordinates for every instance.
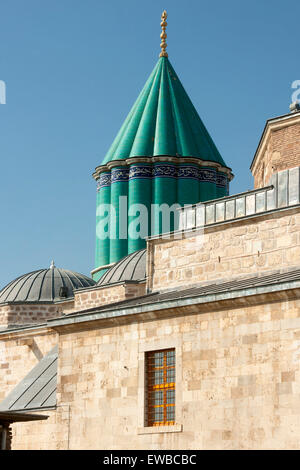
[0,0,300,287]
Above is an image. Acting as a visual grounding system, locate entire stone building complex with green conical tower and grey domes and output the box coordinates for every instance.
[0,15,300,449]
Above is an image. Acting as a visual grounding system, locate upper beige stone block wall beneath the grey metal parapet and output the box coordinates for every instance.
[148,208,300,291]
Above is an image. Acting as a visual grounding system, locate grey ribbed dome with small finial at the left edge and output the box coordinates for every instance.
[0,265,95,304]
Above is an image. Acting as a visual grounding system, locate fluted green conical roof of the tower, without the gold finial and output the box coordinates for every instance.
[102,57,226,166]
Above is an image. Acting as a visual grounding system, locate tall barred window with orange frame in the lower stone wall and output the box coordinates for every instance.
[146,349,175,426]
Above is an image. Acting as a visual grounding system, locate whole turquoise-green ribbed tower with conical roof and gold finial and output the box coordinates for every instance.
[92,11,233,280]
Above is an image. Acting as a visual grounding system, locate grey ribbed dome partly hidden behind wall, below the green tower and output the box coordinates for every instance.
[97,250,146,286]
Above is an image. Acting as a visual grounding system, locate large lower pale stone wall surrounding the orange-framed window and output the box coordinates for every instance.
[32,294,300,450]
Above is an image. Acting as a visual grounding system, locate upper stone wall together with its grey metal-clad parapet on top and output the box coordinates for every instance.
[148,168,300,291]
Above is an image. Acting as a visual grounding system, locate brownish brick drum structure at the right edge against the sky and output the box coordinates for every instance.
[251,113,300,188]
